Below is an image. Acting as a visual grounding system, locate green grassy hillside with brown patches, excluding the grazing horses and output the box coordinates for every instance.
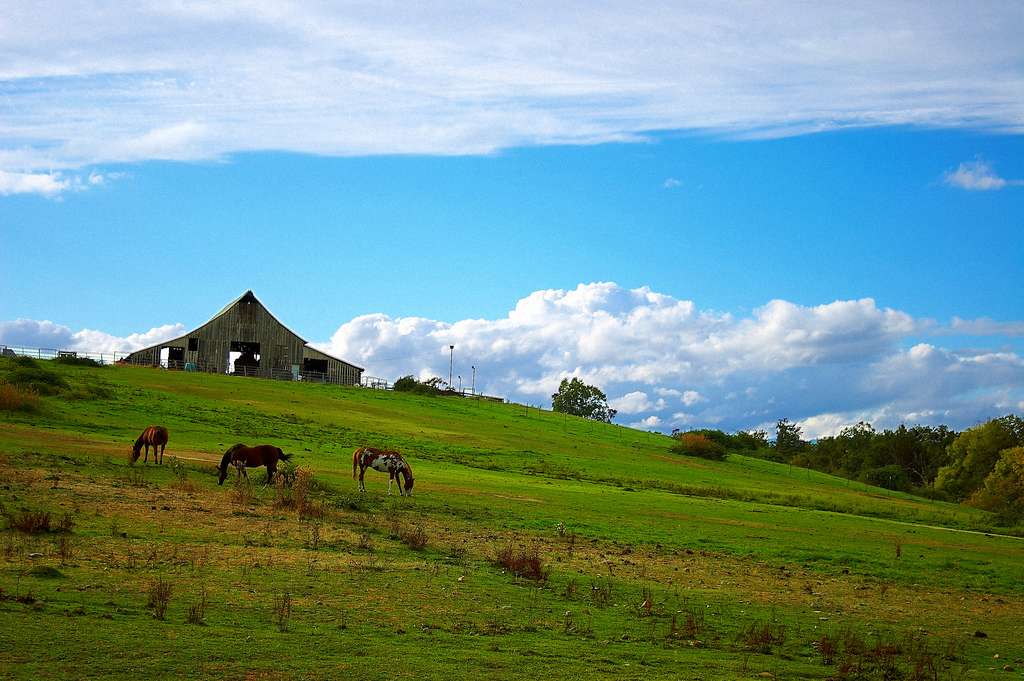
[0,360,1024,679]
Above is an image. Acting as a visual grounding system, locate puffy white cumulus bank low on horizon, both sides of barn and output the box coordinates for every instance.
[0,283,1024,437]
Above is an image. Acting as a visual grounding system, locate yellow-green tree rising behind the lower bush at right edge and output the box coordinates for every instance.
[935,415,1024,500]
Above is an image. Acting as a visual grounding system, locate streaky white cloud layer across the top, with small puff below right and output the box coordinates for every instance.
[0,0,1024,197]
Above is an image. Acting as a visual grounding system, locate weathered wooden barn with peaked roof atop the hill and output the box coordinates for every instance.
[125,291,362,385]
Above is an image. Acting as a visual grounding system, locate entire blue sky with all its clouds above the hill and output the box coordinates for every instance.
[0,3,1024,433]
